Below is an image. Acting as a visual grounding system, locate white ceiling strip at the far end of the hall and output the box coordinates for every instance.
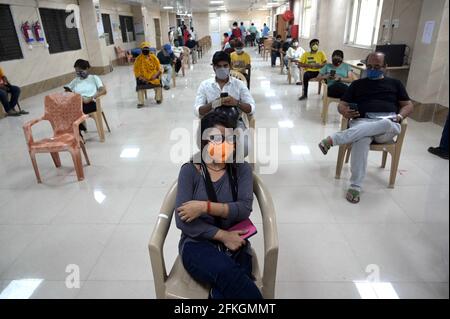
[119,0,287,13]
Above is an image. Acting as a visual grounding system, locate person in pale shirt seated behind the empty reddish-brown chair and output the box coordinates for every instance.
[64,59,106,131]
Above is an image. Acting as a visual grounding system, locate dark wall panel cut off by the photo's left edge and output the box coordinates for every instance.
[0,4,23,61]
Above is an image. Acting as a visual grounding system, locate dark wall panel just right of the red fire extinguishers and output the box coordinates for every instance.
[39,8,81,54]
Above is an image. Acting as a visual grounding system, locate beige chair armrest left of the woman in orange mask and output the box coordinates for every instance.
[148,182,177,298]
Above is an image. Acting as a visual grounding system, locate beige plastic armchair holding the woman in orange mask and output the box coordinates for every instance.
[148,173,278,299]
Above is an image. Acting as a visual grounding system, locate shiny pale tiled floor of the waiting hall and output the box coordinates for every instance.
[0,47,449,298]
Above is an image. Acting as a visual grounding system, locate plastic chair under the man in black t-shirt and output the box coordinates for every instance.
[335,117,408,188]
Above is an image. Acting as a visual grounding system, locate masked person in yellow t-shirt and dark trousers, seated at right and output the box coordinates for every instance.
[299,39,327,100]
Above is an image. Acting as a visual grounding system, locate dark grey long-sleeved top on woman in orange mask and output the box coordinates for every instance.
[174,163,253,254]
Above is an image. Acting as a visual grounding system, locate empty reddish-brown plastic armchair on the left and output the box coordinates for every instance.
[23,92,90,183]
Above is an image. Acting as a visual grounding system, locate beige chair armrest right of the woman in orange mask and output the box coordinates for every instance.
[253,173,279,299]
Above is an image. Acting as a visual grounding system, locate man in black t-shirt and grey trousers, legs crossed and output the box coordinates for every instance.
[319,52,413,204]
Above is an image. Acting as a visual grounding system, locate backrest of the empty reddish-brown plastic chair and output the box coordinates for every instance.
[44,92,83,135]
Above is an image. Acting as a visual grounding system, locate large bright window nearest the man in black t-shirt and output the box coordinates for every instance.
[346,0,383,48]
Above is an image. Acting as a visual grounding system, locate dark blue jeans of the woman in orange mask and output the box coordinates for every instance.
[181,241,262,299]
